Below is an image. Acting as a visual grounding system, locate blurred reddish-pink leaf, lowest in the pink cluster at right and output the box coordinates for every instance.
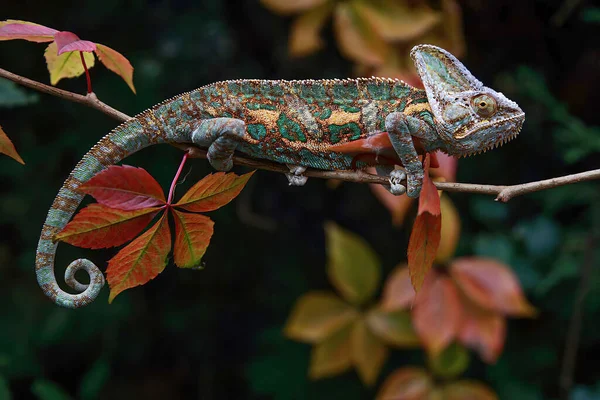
[458,301,506,364]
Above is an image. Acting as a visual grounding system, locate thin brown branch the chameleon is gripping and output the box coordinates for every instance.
[0,68,600,202]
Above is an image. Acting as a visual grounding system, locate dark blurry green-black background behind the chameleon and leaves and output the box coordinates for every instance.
[0,0,600,400]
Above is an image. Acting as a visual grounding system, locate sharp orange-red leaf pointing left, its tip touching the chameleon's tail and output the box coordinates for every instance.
[54,203,160,249]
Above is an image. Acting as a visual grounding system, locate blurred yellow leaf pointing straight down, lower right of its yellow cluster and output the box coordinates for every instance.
[352,319,389,386]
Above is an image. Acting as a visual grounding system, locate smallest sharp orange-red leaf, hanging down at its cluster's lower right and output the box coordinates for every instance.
[173,210,214,268]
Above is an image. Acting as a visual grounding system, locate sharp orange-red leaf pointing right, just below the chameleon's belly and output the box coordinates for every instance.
[174,171,254,212]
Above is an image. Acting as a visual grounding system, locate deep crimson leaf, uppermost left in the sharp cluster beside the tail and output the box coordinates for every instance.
[79,165,165,210]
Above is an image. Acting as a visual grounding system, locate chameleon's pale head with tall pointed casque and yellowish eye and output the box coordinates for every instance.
[410,45,525,156]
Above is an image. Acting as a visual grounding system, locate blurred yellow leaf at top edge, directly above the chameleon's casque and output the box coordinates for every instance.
[355,0,441,42]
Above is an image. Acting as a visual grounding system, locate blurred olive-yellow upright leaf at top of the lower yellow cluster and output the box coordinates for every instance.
[325,222,381,305]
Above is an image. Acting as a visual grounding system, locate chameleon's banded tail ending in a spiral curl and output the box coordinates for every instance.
[35,110,189,308]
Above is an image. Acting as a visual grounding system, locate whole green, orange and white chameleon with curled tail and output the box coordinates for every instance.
[35,45,525,308]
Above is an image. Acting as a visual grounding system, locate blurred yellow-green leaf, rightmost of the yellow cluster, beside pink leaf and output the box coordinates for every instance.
[367,309,420,347]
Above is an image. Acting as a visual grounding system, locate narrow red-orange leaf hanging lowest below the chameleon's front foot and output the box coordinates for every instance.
[408,212,442,292]
